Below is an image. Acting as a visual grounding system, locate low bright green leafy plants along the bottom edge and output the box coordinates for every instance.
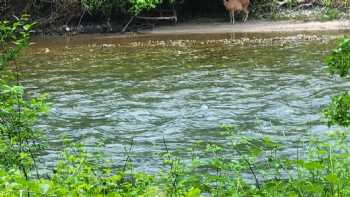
[0,129,350,197]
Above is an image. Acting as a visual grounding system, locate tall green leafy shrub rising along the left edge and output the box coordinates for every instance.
[0,16,46,182]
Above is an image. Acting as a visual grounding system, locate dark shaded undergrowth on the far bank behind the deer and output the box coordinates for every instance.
[0,0,350,31]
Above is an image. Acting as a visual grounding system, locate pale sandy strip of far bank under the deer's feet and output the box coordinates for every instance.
[143,20,350,34]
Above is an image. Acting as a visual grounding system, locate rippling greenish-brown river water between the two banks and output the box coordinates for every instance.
[22,33,350,169]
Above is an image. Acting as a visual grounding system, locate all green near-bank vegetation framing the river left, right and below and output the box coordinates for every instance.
[0,16,350,197]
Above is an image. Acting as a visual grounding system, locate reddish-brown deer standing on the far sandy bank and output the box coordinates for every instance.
[223,0,250,24]
